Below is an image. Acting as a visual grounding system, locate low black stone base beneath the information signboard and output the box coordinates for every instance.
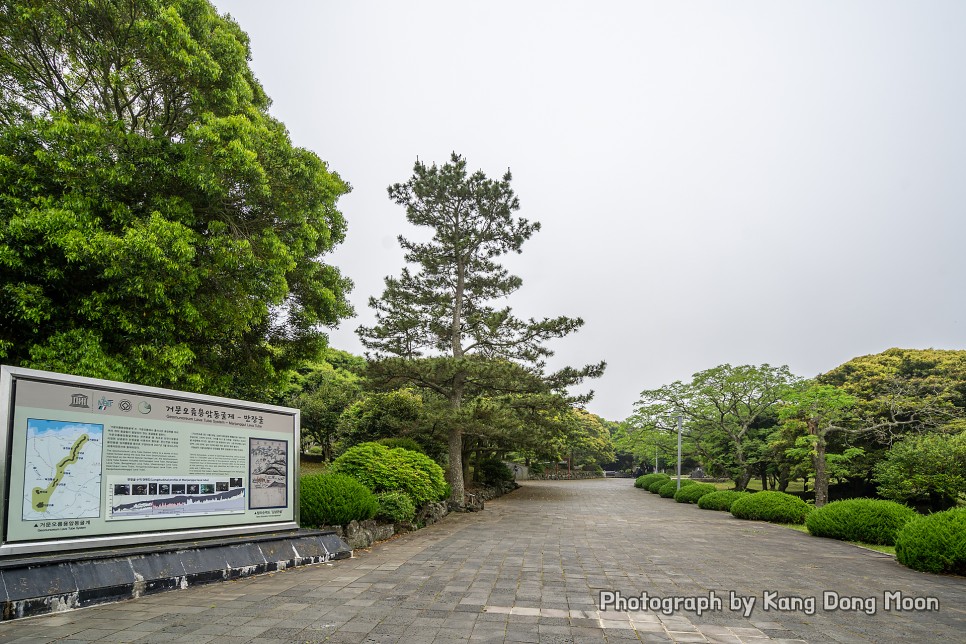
[0,530,352,620]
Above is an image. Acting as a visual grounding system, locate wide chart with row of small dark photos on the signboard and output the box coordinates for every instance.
[107,475,245,521]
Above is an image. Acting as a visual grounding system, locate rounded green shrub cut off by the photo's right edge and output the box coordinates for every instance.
[896,508,966,575]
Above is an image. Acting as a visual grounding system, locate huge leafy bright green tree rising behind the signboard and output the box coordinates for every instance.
[0,0,351,399]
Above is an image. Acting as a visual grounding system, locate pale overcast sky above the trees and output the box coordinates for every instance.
[215,0,966,420]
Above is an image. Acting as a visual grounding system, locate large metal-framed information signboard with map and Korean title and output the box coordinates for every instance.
[0,367,299,555]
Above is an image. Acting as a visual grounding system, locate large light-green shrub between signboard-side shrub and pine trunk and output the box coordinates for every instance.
[330,443,449,507]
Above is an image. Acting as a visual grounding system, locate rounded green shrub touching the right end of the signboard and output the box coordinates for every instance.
[299,472,379,528]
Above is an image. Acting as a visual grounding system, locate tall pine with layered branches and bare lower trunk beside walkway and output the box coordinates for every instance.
[359,153,604,506]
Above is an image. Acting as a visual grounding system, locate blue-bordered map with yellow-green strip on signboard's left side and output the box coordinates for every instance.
[23,418,104,521]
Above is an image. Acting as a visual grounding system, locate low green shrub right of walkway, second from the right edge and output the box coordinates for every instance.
[805,499,916,546]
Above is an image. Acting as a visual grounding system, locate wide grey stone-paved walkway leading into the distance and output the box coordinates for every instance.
[0,479,966,644]
